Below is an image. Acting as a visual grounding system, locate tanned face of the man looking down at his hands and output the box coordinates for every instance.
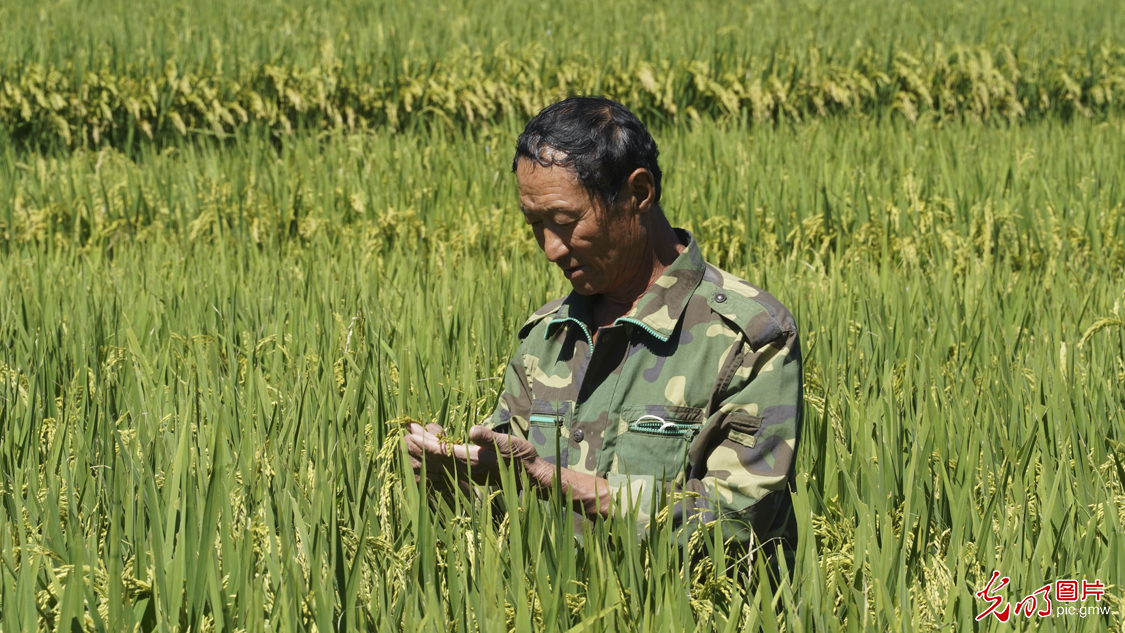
[515,159,642,296]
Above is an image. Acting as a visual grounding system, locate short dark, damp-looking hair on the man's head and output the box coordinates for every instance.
[512,97,660,207]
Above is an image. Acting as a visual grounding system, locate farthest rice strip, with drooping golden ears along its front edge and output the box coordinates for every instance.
[0,0,1125,148]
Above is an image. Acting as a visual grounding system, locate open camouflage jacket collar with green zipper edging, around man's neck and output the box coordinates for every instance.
[543,228,707,342]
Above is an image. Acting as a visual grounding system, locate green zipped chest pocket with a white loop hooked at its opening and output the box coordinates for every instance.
[611,405,703,481]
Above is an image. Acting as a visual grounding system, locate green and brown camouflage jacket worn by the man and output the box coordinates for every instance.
[488,229,802,551]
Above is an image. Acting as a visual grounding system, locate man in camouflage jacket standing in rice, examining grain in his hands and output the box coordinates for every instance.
[406,97,802,562]
